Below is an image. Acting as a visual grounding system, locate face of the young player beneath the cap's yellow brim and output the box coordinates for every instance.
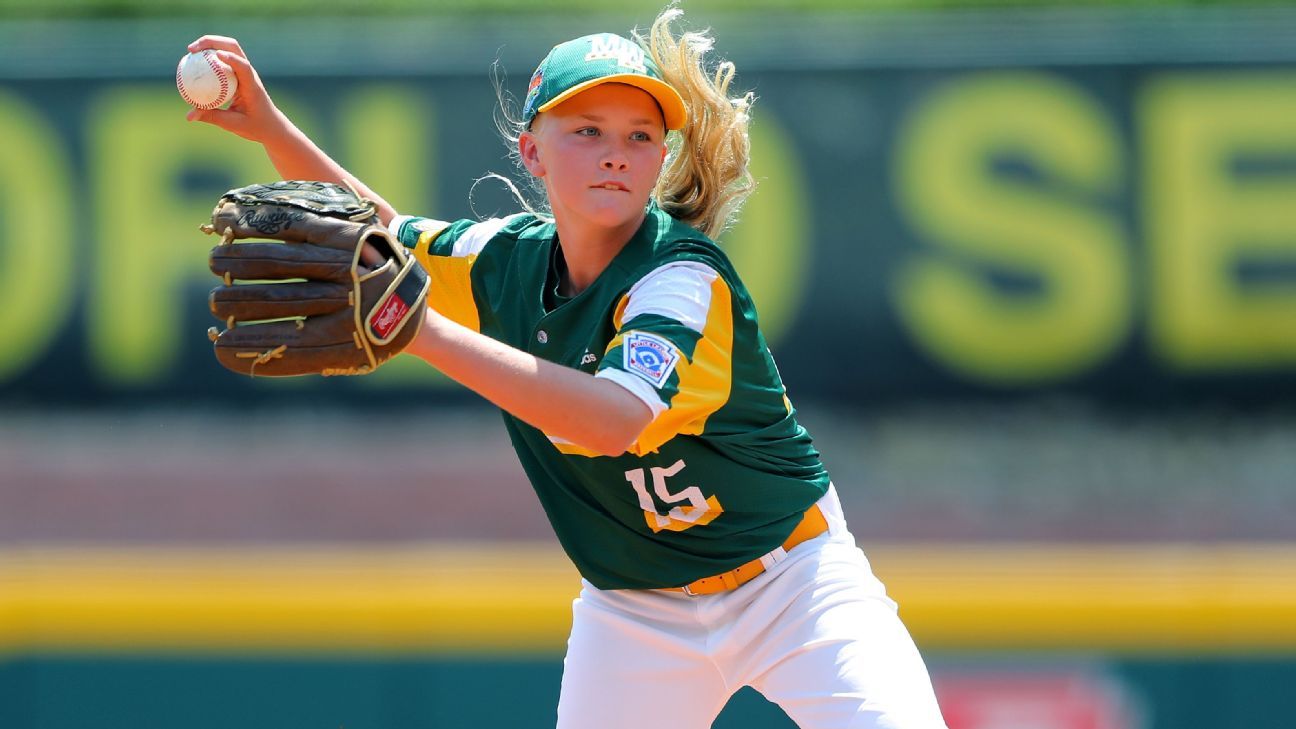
[522,83,666,236]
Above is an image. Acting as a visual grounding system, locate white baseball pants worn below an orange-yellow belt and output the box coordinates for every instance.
[557,488,945,729]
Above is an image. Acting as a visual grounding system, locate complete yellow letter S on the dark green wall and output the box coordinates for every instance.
[893,73,1131,387]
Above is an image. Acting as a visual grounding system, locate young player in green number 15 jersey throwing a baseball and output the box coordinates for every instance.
[189,10,945,729]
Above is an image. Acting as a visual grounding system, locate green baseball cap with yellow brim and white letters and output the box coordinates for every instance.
[522,32,688,130]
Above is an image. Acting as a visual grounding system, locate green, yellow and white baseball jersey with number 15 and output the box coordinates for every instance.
[391,205,828,589]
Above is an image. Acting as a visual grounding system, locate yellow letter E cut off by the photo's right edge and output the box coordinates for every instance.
[1138,73,1296,371]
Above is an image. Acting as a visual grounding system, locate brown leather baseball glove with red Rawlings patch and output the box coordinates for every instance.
[202,180,428,376]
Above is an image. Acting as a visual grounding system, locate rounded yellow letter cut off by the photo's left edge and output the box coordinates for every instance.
[0,90,74,383]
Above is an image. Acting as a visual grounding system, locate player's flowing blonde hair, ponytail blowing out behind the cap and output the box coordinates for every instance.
[495,6,756,239]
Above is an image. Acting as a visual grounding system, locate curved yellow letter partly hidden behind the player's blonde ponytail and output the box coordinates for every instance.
[718,113,814,344]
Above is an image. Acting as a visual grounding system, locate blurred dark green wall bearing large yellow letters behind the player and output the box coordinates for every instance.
[0,10,1296,407]
